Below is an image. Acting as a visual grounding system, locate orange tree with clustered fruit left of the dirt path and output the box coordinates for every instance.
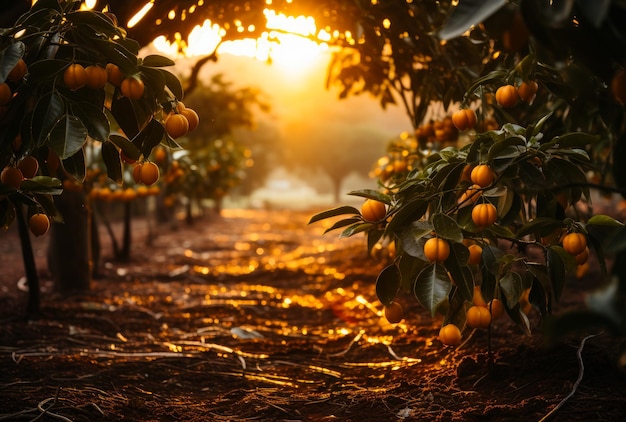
[0,0,183,310]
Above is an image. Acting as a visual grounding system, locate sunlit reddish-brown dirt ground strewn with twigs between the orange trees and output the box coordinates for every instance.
[0,210,626,421]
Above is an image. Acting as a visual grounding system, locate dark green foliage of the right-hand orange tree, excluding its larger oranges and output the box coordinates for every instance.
[311,1,624,333]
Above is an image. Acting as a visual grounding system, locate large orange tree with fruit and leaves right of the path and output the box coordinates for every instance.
[311,0,626,350]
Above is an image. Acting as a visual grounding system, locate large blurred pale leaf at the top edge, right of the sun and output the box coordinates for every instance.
[438,0,506,40]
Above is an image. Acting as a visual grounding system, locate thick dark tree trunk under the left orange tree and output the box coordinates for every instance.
[48,190,91,292]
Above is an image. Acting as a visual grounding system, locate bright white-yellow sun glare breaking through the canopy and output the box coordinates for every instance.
[154,9,330,74]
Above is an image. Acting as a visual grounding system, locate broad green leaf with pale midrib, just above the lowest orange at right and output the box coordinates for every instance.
[413,263,452,317]
